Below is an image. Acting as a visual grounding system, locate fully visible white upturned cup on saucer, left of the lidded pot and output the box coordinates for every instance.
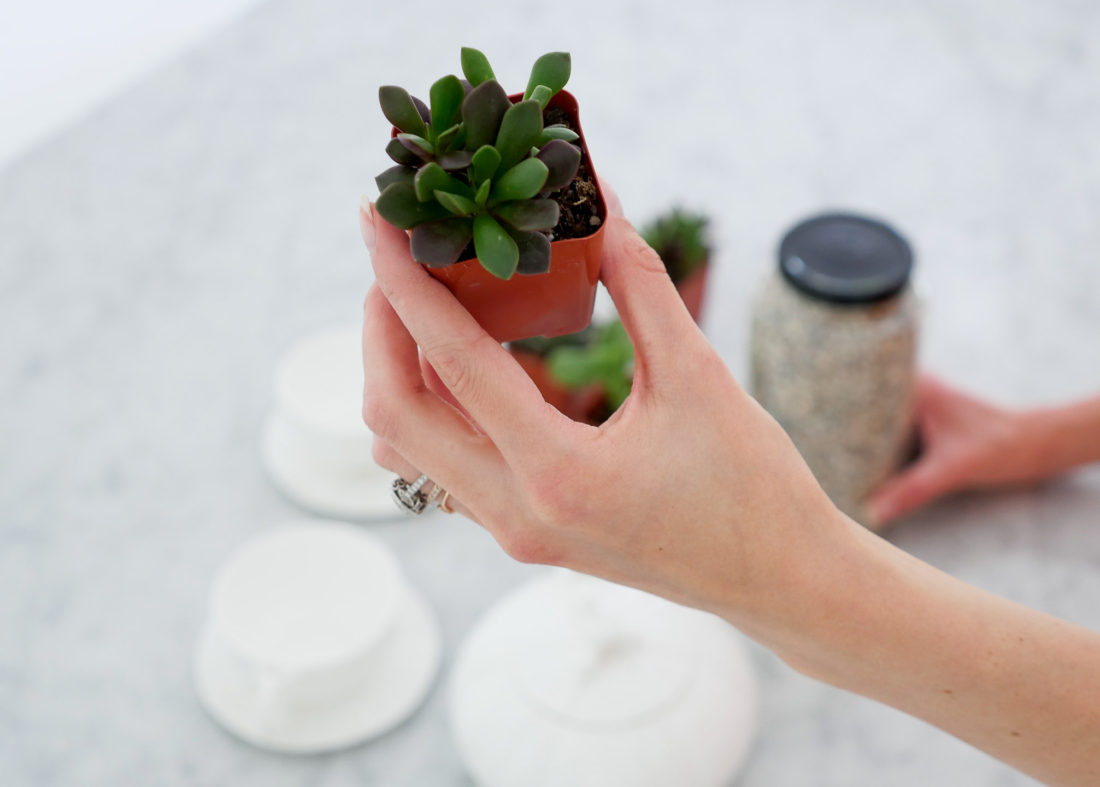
[196,521,440,753]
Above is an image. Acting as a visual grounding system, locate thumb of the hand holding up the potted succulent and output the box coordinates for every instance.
[600,216,699,361]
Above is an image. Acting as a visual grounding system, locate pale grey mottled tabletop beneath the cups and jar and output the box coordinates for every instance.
[0,0,1100,787]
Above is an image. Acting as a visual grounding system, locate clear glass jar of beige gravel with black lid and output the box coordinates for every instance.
[751,214,919,524]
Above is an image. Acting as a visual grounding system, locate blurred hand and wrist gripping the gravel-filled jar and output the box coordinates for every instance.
[871,376,1100,526]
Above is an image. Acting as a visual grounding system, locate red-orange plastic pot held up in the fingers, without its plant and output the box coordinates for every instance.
[393,90,607,341]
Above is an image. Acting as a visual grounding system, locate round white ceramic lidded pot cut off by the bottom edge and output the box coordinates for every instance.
[450,571,756,787]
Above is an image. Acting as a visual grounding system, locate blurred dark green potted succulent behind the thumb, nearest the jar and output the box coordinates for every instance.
[641,208,711,323]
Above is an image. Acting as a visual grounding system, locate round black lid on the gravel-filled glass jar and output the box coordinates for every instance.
[779,214,913,304]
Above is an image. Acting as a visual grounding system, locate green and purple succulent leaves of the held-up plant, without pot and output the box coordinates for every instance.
[375,47,581,278]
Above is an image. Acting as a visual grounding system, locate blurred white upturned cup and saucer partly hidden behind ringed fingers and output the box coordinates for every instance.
[262,327,395,520]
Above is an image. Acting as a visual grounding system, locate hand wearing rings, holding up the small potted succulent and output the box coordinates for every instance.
[361,206,848,635]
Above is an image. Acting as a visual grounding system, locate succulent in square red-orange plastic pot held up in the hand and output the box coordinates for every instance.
[375,48,607,341]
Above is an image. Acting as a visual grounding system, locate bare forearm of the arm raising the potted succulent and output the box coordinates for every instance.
[734,517,1100,785]
